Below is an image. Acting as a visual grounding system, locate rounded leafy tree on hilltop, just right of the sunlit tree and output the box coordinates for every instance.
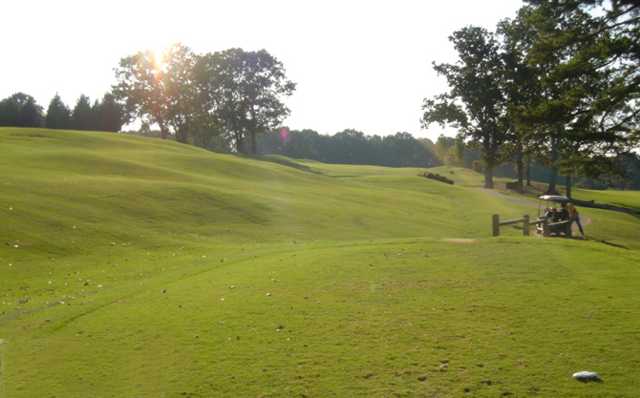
[196,48,295,154]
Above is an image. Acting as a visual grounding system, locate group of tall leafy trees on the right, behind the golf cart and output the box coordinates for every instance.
[422,0,640,193]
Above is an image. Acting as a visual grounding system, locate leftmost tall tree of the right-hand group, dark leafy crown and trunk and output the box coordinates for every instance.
[422,26,508,188]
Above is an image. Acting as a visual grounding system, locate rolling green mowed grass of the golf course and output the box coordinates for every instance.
[0,128,640,398]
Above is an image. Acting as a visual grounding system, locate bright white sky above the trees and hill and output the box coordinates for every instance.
[0,0,522,139]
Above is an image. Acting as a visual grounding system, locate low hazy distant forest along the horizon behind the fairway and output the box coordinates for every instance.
[258,129,640,189]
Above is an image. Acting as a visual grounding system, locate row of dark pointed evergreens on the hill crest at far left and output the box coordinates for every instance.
[0,93,124,132]
